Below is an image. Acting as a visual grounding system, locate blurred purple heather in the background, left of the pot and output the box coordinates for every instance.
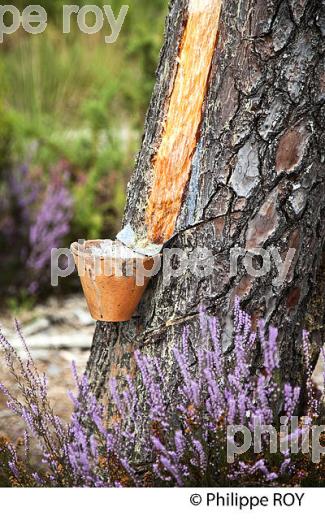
[0,163,72,298]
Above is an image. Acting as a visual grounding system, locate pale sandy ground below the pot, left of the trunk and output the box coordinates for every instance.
[0,295,95,440]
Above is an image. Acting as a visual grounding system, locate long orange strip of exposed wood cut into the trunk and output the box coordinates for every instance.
[146,0,221,243]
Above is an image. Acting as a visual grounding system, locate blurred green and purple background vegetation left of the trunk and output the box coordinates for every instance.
[0,0,168,305]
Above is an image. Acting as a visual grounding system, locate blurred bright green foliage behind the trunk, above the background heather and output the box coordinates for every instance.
[0,0,168,246]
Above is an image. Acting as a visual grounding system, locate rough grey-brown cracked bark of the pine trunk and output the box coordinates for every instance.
[87,0,325,406]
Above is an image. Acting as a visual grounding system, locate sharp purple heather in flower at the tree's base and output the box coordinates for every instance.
[0,302,324,487]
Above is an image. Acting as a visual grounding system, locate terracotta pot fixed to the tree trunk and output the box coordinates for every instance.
[71,240,154,322]
